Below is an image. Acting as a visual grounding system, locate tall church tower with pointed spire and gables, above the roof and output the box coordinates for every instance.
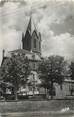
[22,18,41,55]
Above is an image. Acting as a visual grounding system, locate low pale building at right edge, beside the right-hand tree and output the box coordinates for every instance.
[54,79,74,99]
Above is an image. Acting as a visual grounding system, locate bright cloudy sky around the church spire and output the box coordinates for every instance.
[0,0,74,63]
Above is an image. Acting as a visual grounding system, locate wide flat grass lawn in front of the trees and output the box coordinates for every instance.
[0,100,74,113]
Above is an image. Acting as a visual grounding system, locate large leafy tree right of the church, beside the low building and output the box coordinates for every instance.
[38,56,70,99]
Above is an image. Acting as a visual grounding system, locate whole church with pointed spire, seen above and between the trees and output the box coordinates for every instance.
[1,17,41,98]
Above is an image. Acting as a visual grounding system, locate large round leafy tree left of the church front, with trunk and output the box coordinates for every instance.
[1,54,30,99]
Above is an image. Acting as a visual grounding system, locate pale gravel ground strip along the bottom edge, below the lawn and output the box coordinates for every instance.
[0,111,74,117]
